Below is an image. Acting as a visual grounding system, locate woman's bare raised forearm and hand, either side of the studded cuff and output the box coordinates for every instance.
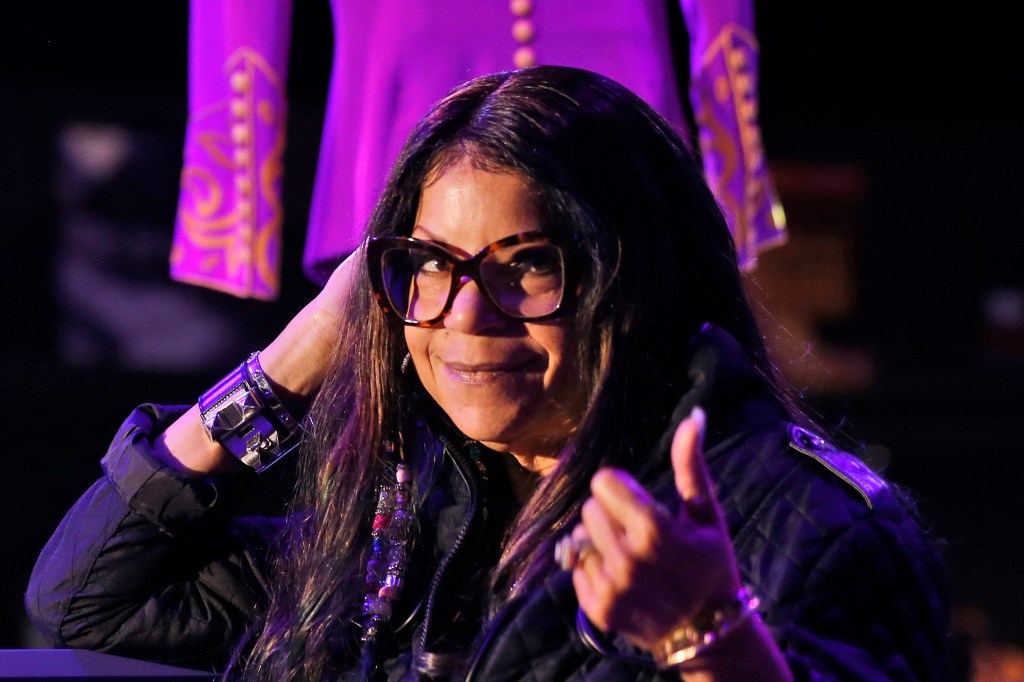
[149,248,364,475]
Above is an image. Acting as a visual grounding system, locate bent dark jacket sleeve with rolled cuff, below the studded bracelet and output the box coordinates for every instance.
[26,406,283,666]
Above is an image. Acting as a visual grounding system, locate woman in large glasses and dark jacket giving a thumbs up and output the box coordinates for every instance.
[28,67,945,680]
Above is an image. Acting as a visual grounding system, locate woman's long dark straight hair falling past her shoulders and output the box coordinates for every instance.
[237,67,770,680]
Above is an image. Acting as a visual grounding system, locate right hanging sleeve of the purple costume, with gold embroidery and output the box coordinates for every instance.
[680,0,786,268]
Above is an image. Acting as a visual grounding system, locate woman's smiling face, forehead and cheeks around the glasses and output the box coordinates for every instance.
[406,158,581,466]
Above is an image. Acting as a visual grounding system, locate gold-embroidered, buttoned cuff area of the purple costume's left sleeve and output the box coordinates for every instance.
[172,47,285,299]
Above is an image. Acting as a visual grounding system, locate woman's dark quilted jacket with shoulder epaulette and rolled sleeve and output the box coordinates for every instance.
[26,329,948,682]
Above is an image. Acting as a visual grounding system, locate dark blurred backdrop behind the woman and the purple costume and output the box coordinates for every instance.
[0,0,1024,667]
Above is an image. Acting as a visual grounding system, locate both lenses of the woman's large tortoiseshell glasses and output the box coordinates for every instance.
[382,244,565,322]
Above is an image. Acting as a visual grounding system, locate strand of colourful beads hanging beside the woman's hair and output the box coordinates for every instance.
[361,443,413,662]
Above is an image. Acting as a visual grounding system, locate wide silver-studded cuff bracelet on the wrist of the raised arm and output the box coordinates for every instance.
[199,351,302,466]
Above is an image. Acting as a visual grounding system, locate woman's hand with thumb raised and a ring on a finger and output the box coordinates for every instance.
[572,410,740,649]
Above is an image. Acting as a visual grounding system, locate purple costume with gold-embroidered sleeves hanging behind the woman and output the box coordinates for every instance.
[171,0,785,299]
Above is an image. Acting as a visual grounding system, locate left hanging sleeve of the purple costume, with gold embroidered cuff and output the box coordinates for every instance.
[171,0,292,300]
